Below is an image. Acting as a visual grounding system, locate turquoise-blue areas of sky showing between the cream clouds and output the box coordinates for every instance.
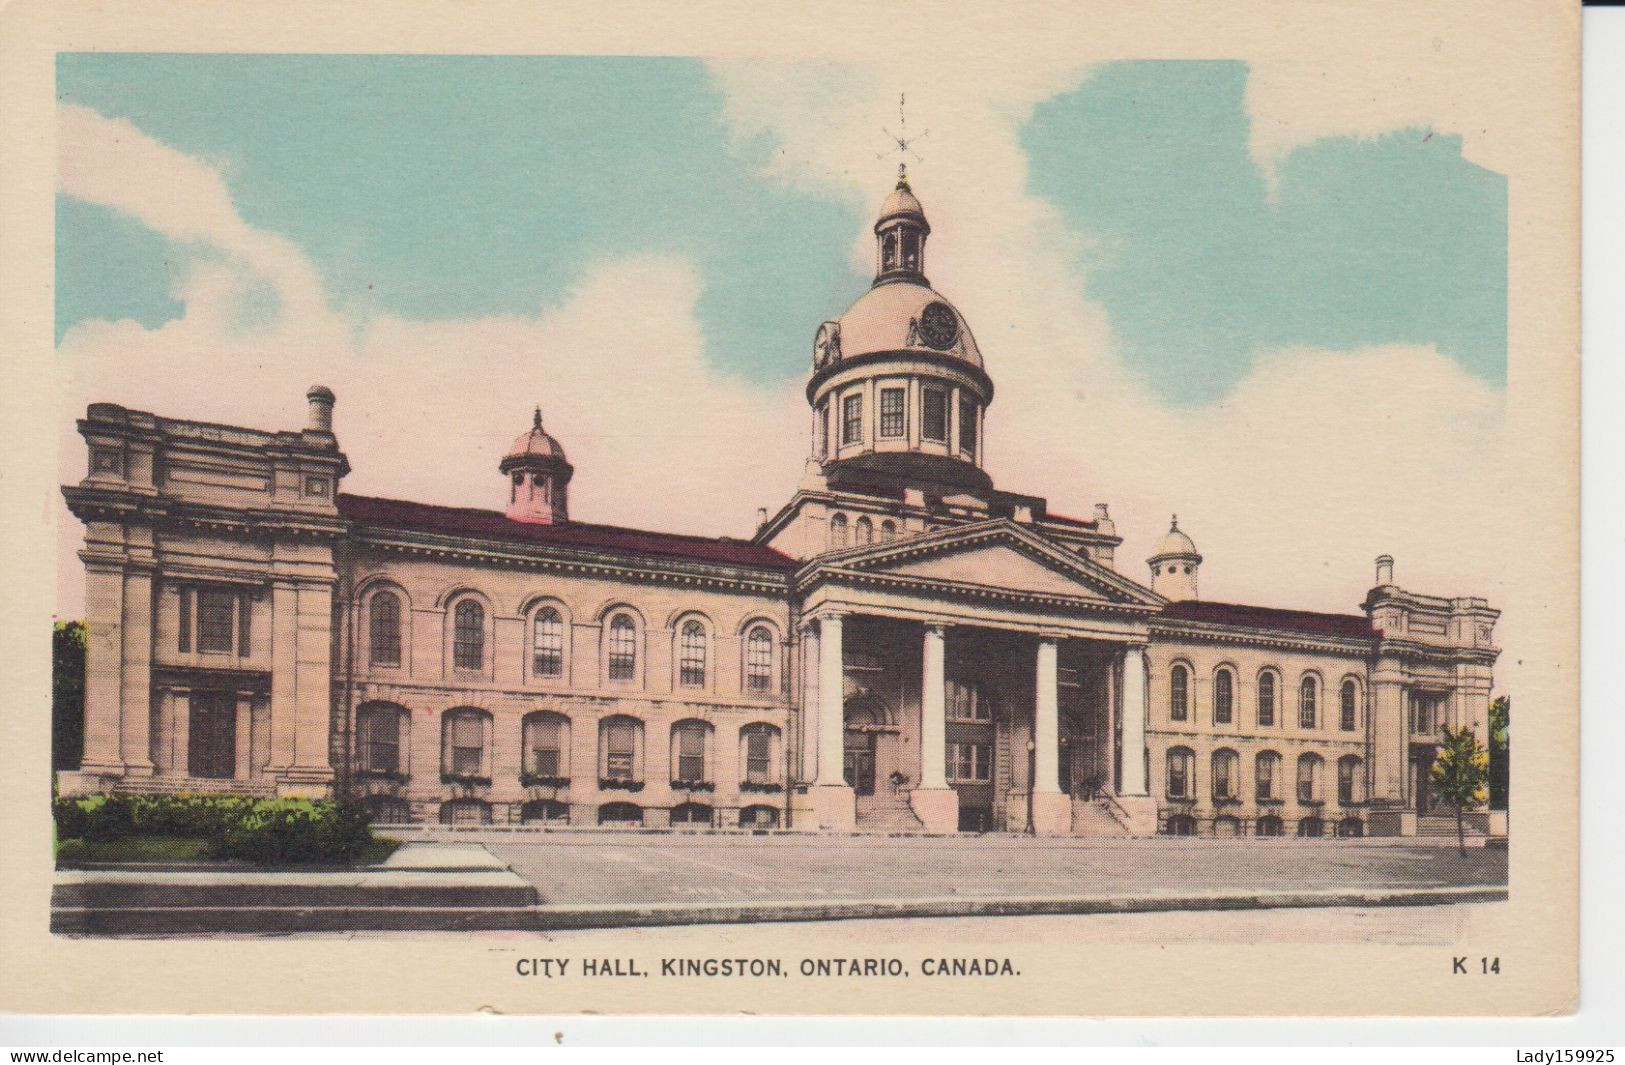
[57,54,1506,405]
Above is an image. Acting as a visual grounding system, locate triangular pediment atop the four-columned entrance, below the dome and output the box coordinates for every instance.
[827,520,1162,606]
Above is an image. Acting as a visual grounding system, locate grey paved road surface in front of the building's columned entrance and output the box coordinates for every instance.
[457,832,1506,904]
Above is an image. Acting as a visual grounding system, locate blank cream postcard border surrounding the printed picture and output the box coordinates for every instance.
[0,0,1580,1016]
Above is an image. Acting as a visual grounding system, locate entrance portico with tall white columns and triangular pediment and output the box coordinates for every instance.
[798,520,1157,836]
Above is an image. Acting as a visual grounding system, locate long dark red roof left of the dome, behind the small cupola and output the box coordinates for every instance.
[338,493,798,572]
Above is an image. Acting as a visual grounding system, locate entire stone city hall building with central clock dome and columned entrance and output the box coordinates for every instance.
[60,179,1498,836]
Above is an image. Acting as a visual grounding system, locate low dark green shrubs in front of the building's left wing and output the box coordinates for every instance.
[52,795,372,865]
